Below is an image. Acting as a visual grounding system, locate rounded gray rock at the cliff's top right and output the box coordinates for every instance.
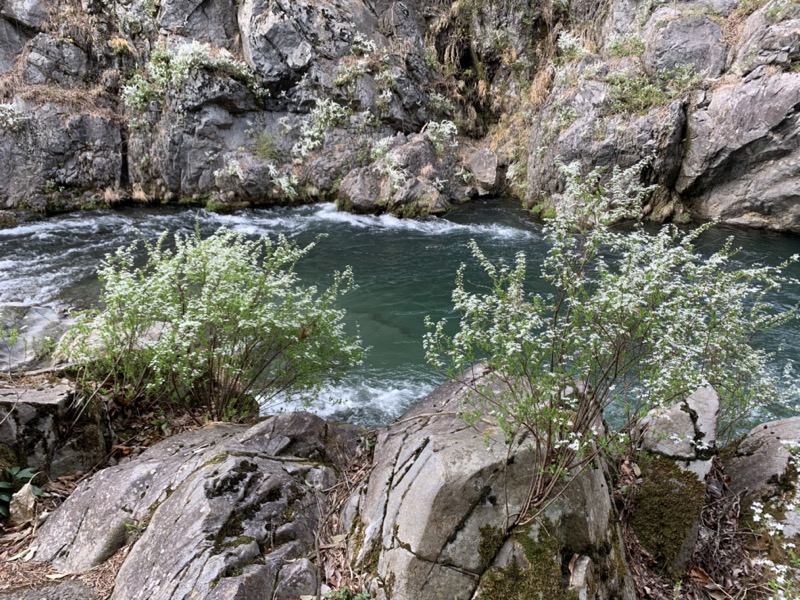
[644,5,727,78]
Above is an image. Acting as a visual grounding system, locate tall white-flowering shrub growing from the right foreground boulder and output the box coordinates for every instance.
[425,165,796,520]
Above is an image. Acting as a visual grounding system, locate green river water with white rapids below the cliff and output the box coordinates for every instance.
[0,200,800,426]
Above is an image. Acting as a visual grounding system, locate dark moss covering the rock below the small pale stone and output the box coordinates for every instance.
[632,454,705,575]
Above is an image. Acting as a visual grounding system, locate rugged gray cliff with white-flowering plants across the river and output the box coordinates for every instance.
[0,0,800,231]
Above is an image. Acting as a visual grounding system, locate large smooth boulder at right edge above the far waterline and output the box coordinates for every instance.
[675,66,800,231]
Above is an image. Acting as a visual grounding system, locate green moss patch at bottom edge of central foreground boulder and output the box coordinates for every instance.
[478,528,578,600]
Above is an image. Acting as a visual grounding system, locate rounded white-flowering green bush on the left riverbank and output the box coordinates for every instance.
[62,229,363,420]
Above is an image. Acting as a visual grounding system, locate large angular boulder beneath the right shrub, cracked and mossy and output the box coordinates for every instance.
[351,370,634,600]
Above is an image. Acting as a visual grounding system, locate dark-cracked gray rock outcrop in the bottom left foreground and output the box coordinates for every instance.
[36,413,358,600]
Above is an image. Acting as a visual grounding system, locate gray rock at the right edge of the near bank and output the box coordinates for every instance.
[725,417,800,500]
